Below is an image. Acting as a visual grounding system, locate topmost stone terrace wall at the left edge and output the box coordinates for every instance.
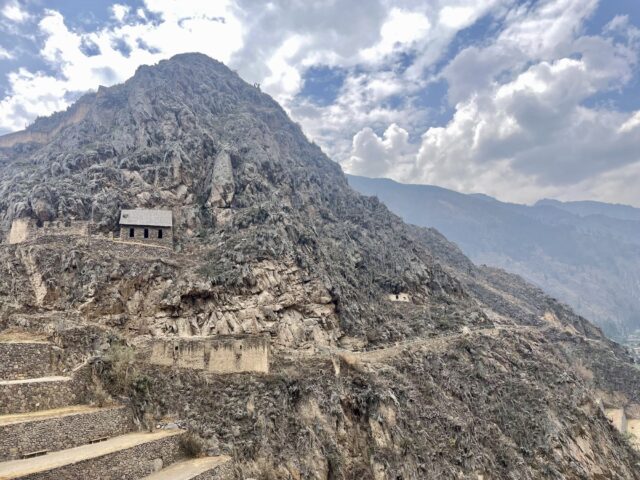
[0,341,62,380]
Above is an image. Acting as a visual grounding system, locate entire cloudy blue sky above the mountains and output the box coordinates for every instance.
[0,0,640,207]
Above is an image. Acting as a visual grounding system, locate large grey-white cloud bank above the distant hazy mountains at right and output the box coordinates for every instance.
[345,0,640,205]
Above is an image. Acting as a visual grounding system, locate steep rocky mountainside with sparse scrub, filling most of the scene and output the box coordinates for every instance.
[0,54,640,479]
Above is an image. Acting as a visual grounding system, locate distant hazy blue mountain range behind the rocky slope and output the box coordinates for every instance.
[349,176,640,340]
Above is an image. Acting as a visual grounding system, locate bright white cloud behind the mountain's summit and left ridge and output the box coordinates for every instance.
[0,0,242,131]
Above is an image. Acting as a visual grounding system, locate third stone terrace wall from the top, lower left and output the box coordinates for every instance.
[0,406,133,462]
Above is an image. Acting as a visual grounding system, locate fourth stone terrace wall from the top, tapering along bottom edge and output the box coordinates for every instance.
[22,435,182,480]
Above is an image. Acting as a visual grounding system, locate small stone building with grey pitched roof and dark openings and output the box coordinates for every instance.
[120,209,173,247]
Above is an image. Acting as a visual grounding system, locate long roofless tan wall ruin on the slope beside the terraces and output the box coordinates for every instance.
[145,335,269,374]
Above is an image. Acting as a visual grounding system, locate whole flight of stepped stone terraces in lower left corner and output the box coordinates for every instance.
[0,335,231,480]
